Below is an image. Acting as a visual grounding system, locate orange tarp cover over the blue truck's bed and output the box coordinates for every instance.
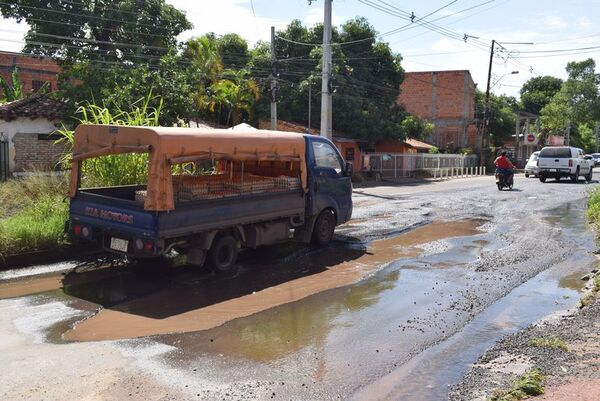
[69,124,307,211]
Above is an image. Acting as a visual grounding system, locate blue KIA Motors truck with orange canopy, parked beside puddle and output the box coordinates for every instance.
[69,125,352,271]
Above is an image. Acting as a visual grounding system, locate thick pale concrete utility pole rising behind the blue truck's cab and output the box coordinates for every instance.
[321,0,333,139]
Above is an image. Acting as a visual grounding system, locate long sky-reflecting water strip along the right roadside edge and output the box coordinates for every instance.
[353,200,598,401]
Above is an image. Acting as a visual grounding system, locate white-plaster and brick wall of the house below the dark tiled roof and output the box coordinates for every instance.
[0,117,65,173]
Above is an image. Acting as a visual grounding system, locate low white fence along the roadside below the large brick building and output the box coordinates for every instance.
[365,153,485,178]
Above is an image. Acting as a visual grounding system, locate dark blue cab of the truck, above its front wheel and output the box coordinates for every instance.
[309,137,352,224]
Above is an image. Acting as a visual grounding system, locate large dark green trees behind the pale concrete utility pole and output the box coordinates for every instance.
[250,18,407,143]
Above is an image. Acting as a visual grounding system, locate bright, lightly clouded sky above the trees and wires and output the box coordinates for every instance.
[0,0,600,96]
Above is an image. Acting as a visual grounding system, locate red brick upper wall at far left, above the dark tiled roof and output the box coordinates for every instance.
[0,52,60,92]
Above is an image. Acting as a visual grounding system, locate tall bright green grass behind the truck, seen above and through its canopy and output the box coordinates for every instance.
[57,91,163,187]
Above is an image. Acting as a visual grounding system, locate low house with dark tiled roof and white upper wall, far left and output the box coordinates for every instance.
[0,95,66,175]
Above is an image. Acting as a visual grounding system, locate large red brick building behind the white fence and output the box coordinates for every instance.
[397,70,481,151]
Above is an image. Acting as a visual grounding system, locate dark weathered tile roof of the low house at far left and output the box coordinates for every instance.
[0,95,67,121]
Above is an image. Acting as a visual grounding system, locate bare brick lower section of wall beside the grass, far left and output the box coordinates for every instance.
[13,133,65,171]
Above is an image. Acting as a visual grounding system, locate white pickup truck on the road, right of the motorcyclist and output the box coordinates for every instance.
[537,146,594,182]
